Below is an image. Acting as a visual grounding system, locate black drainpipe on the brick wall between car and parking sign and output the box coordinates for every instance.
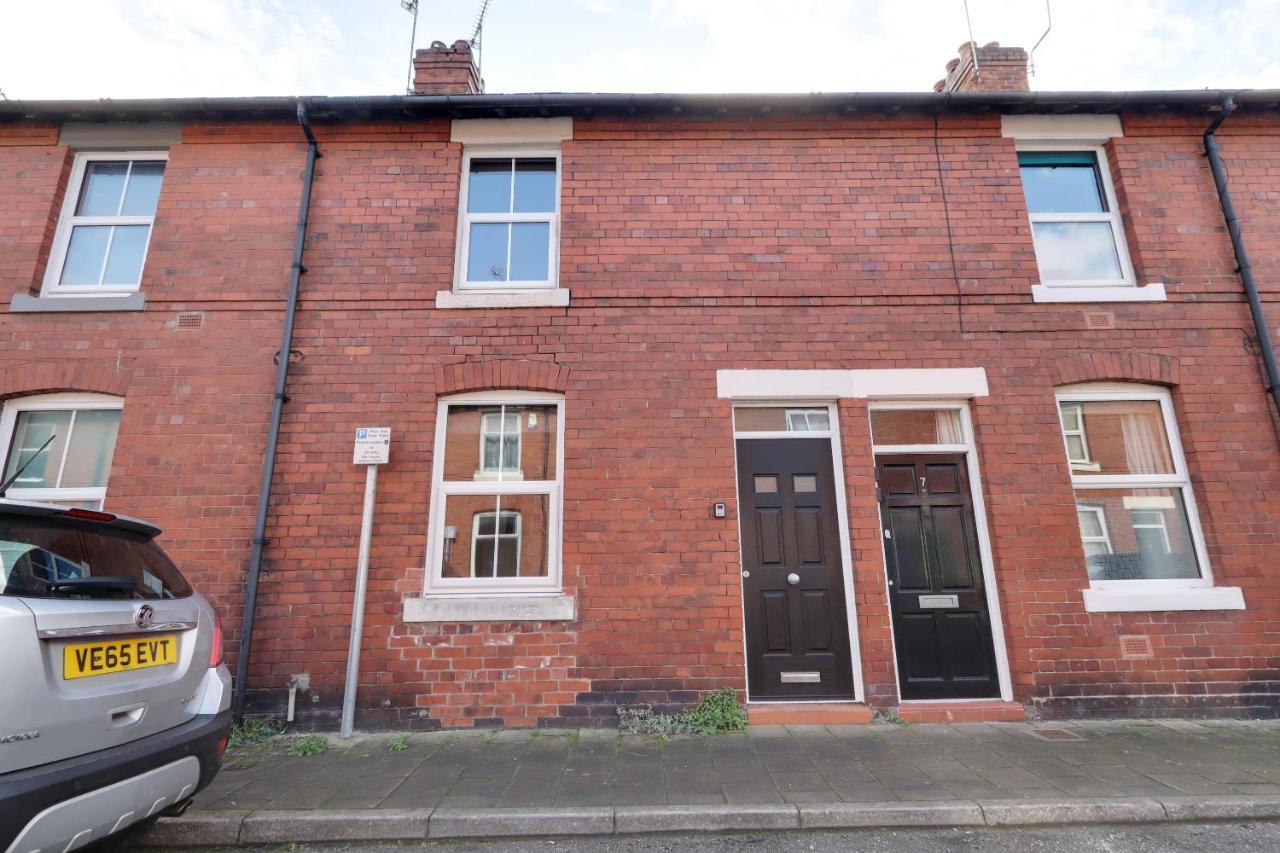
[232,101,323,722]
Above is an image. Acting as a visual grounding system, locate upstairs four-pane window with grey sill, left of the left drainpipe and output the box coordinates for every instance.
[44,151,165,296]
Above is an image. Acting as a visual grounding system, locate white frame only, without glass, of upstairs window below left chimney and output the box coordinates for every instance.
[453,145,563,293]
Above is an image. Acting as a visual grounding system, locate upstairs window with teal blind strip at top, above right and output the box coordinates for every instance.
[1018,149,1134,287]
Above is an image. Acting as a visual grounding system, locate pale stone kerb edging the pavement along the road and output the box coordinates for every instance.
[137,797,1280,847]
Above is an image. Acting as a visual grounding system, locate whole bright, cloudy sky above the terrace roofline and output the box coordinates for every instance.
[0,0,1280,100]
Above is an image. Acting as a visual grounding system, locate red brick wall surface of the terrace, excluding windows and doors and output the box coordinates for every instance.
[0,108,1280,726]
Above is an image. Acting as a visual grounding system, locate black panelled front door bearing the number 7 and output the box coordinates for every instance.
[876,453,1000,699]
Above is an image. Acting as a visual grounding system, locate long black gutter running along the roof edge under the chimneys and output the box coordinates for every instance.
[0,90,1280,122]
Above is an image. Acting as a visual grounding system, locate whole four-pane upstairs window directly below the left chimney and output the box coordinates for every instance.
[458,152,559,289]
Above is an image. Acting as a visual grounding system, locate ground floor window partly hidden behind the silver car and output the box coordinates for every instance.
[0,394,120,510]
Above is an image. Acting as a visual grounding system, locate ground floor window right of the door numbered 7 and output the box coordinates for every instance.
[1059,386,1207,584]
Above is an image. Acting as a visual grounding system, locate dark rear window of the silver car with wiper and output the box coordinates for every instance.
[0,515,191,598]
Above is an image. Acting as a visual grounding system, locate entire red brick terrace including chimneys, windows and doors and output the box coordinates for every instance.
[0,42,1280,727]
